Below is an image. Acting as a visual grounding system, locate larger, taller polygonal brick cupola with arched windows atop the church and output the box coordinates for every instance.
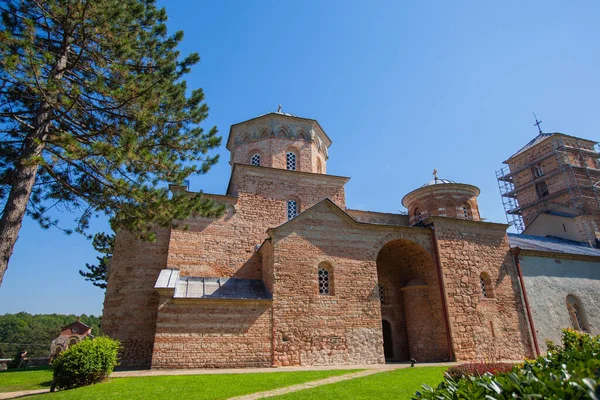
[227,106,331,174]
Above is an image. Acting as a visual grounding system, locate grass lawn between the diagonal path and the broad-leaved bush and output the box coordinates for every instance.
[274,367,448,400]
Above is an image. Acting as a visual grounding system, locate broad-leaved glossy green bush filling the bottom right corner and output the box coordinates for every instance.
[413,330,600,400]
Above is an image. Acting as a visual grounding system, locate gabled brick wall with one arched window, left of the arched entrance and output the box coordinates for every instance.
[272,202,446,366]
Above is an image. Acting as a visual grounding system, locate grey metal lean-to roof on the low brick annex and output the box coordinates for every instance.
[154,269,272,300]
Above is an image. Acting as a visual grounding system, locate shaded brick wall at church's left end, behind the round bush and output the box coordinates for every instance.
[102,229,169,367]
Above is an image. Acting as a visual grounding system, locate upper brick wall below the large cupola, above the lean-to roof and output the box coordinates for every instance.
[168,165,345,279]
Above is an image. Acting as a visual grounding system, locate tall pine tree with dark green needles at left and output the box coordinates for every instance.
[0,0,222,284]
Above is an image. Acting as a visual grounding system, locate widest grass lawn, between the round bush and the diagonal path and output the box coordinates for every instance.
[30,370,357,400]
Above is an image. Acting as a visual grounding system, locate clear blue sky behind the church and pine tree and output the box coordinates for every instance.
[0,0,600,315]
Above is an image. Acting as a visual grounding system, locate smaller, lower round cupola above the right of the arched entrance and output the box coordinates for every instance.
[402,170,480,225]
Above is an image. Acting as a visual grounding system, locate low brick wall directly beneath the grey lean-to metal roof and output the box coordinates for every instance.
[152,297,271,368]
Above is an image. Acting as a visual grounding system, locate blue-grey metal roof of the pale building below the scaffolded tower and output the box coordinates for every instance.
[508,233,600,257]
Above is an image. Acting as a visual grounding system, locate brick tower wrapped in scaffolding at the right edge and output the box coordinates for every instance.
[496,133,600,233]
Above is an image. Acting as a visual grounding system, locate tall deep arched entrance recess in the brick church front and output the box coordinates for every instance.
[377,239,448,362]
